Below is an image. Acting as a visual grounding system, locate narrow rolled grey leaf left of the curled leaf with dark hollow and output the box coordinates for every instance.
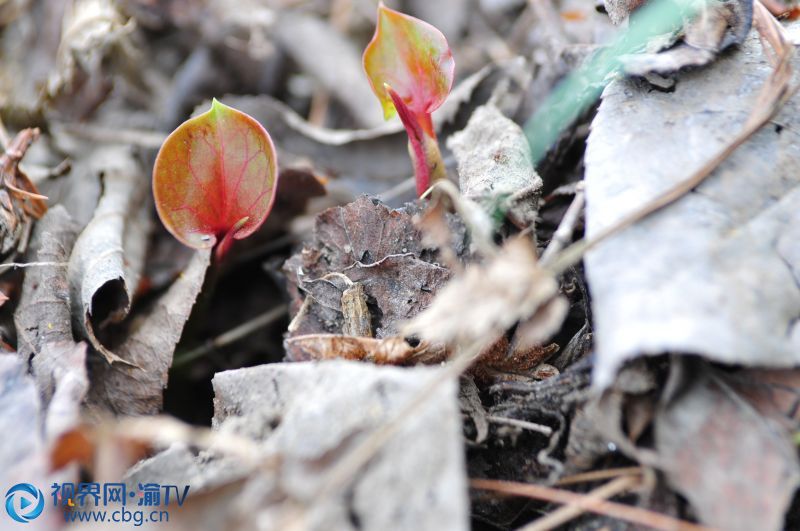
[14,205,77,360]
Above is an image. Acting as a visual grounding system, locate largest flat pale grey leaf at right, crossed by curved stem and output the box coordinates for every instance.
[585,27,800,387]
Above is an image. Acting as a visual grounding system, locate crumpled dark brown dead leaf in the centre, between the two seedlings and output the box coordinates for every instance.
[283,196,450,339]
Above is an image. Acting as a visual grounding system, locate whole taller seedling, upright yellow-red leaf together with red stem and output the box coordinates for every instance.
[363,3,455,196]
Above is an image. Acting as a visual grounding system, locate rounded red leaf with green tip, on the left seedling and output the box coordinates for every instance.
[153,100,278,257]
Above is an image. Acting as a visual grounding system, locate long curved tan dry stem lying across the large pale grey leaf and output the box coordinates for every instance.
[541,2,798,274]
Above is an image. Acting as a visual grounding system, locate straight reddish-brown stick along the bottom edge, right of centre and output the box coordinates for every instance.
[470,479,711,531]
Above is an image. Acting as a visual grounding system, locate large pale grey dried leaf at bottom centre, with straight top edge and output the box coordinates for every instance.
[212,361,469,531]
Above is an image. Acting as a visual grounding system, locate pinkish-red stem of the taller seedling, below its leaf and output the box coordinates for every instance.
[385,85,447,196]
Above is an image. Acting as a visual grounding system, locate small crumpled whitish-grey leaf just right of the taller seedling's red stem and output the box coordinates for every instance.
[447,104,542,227]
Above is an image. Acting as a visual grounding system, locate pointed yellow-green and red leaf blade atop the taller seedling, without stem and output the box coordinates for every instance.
[364,4,455,124]
